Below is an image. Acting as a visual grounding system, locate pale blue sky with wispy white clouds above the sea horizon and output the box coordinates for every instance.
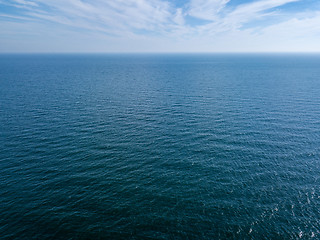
[0,0,320,53]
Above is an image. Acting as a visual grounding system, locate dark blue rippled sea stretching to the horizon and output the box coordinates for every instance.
[0,55,320,239]
